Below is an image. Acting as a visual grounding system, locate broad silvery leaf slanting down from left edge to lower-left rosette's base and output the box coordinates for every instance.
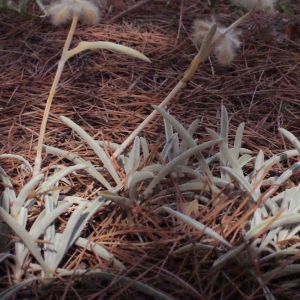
[0,207,50,277]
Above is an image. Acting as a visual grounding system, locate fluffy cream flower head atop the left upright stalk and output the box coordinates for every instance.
[48,0,100,25]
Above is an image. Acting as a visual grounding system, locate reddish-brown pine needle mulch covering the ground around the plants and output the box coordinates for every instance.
[0,0,300,299]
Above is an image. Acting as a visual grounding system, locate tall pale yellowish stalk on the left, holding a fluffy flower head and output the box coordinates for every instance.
[33,13,78,176]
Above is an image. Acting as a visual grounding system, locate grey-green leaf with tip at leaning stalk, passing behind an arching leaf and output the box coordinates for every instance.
[153,105,212,179]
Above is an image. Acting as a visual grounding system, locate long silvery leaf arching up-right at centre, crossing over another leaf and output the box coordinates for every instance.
[143,139,222,195]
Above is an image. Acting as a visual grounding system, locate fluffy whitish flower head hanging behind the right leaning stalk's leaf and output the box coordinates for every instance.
[193,20,241,66]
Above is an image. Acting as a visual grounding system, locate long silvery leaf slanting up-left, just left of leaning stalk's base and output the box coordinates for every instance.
[60,116,121,184]
